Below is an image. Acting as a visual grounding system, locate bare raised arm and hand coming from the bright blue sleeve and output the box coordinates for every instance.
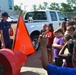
[40,35,49,69]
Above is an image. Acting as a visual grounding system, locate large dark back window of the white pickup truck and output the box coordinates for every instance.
[25,11,47,20]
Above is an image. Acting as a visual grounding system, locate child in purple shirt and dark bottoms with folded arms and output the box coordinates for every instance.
[52,28,64,66]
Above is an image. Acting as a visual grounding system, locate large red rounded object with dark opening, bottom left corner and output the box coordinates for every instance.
[0,49,26,75]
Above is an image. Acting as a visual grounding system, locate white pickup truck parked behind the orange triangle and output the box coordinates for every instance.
[24,10,65,50]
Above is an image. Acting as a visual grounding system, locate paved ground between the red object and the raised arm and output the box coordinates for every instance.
[20,50,47,75]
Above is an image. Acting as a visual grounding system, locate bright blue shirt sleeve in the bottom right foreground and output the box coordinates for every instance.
[46,64,76,75]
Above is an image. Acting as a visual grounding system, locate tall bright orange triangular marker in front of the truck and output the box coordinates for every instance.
[13,14,35,55]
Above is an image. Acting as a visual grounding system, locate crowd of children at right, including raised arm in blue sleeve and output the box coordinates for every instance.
[38,17,76,75]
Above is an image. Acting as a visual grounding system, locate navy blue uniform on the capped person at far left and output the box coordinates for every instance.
[0,20,11,45]
